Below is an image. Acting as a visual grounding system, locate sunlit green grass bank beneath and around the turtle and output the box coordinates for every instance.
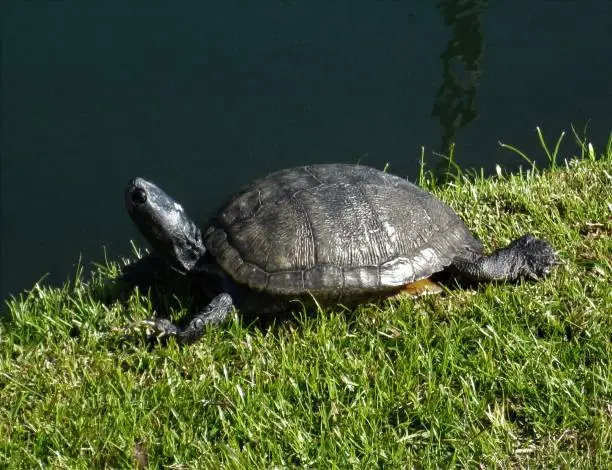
[0,127,612,468]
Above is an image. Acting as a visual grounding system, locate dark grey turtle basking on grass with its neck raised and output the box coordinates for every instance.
[125,163,558,342]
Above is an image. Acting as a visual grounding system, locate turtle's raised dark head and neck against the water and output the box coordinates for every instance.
[125,178,206,273]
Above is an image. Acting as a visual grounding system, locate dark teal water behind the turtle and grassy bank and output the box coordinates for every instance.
[0,0,612,298]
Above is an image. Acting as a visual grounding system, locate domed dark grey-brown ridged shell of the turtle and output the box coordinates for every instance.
[204,164,482,298]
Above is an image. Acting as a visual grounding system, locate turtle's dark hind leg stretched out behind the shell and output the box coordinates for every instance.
[452,235,559,282]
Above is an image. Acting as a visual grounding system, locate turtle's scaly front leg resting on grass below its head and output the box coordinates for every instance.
[145,294,233,343]
